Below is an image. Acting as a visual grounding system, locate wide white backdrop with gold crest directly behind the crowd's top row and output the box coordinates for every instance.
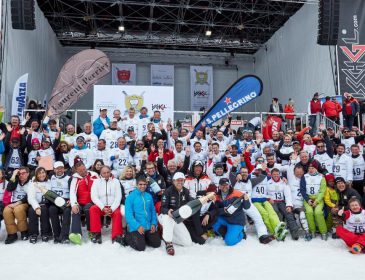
[93,85,174,121]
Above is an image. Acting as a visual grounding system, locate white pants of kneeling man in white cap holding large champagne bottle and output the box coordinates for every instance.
[158,214,192,246]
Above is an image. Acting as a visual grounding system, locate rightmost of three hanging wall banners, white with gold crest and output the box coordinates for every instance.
[190,66,213,111]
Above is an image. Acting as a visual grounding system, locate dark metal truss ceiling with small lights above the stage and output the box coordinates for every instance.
[38,0,304,54]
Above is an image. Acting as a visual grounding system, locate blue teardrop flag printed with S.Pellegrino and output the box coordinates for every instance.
[194,75,263,131]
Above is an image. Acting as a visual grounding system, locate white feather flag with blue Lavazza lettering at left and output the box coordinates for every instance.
[11,73,28,121]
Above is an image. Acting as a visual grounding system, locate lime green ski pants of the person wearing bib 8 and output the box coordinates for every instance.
[304,201,327,234]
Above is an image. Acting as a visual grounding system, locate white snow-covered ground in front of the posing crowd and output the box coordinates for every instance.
[0,225,365,280]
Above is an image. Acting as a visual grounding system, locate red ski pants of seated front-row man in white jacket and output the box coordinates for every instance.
[90,205,123,240]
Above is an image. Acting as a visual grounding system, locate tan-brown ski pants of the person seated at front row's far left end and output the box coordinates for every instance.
[3,203,28,234]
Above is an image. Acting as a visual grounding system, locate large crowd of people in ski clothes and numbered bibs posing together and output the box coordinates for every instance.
[0,105,365,255]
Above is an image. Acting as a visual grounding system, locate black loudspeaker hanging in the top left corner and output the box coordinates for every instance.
[11,0,35,30]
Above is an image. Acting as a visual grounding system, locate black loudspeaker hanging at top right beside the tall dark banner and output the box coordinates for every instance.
[317,0,340,45]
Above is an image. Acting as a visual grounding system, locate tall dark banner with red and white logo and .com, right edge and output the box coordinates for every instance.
[337,0,365,99]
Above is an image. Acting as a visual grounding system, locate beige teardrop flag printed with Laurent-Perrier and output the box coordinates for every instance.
[46,49,110,119]
